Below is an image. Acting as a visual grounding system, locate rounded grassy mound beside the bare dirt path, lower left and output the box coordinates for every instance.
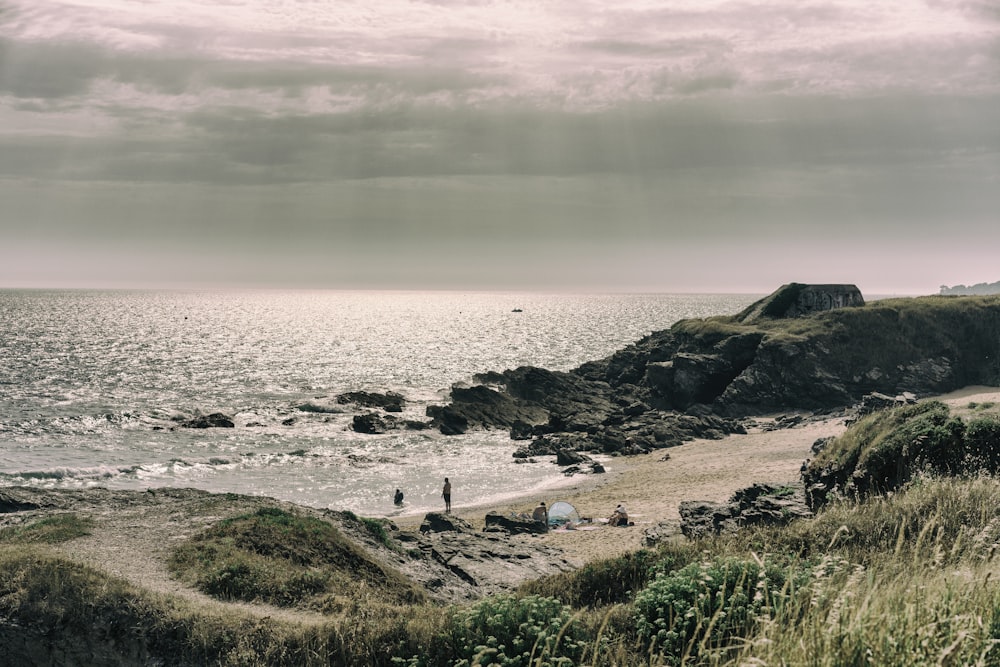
[170,507,424,610]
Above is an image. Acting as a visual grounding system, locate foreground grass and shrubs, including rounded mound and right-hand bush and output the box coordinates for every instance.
[9,402,1000,667]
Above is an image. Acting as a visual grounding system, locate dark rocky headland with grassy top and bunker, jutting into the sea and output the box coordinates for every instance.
[428,283,1000,453]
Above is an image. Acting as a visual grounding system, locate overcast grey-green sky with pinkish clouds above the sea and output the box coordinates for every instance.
[0,0,1000,294]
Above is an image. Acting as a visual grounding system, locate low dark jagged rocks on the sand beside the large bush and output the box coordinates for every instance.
[678,484,812,538]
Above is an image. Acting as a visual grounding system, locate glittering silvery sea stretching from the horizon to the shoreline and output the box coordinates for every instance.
[0,290,757,516]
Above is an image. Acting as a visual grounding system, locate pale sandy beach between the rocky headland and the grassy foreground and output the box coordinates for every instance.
[395,387,1000,564]
